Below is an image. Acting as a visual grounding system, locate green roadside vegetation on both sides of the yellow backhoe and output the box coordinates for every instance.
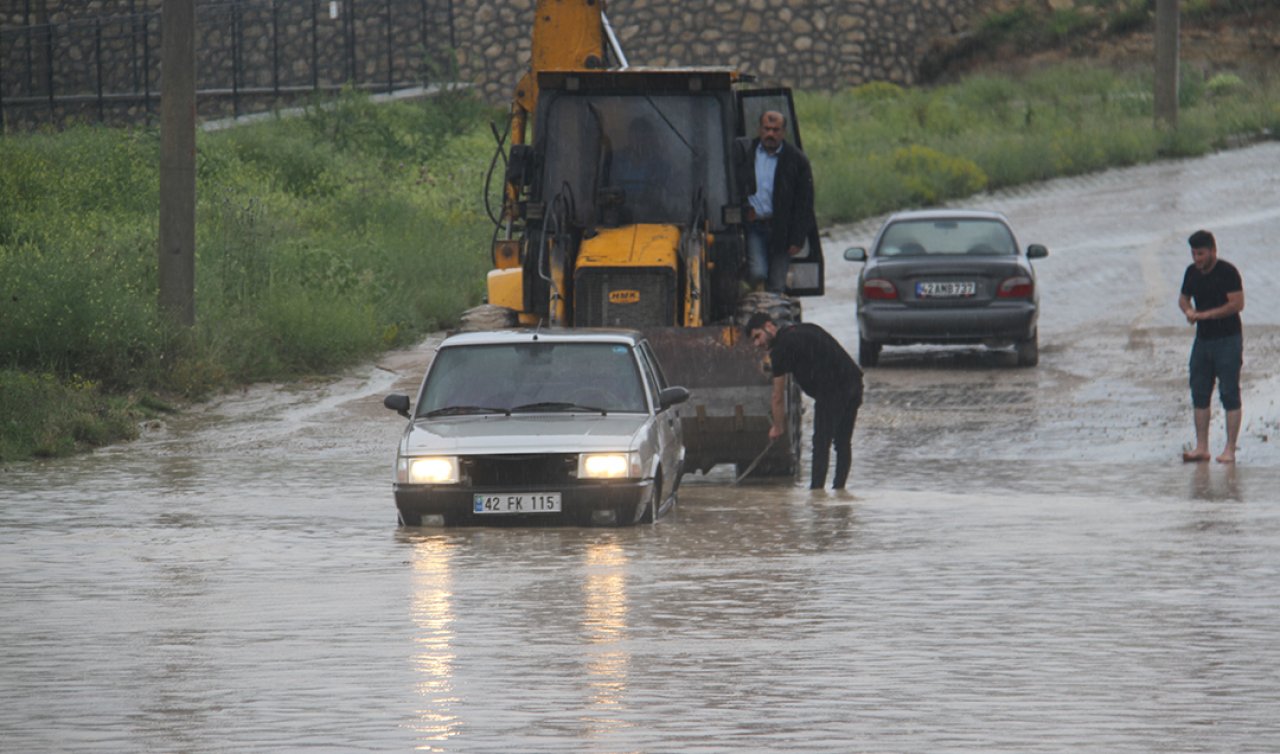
[0,57,1280,462]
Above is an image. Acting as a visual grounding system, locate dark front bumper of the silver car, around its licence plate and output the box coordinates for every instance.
[394,479,654,526]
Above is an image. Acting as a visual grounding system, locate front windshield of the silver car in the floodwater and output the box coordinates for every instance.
[417,341,649,417]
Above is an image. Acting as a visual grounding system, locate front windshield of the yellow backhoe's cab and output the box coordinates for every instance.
[539,93,728,227]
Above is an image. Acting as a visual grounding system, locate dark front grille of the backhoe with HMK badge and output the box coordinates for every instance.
[573,268,676,328]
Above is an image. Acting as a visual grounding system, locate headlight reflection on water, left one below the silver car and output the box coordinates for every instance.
[411,536,462,751]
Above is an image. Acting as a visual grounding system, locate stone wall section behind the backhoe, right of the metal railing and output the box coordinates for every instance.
[454,0,982,101]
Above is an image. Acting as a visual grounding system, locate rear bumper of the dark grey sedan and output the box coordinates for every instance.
[858,302,1037,346]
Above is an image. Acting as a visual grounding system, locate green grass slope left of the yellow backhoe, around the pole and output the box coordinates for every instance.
[0,95,500,461]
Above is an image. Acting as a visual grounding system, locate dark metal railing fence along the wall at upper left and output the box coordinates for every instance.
[0,0,454,129]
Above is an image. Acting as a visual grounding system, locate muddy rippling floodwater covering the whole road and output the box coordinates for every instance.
[0,143,1280,754]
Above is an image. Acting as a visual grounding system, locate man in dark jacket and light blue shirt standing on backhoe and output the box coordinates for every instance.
[746,110,817,293]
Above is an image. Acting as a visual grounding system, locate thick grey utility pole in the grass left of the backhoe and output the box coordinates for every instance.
[159,0,196,326]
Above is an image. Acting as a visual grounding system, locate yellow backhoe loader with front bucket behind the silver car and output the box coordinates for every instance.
[476,0,824,476]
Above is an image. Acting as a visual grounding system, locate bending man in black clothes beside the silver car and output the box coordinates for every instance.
[742,312,863,489]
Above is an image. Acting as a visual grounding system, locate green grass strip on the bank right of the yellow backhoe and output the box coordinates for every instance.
[796,64,1280,225]
